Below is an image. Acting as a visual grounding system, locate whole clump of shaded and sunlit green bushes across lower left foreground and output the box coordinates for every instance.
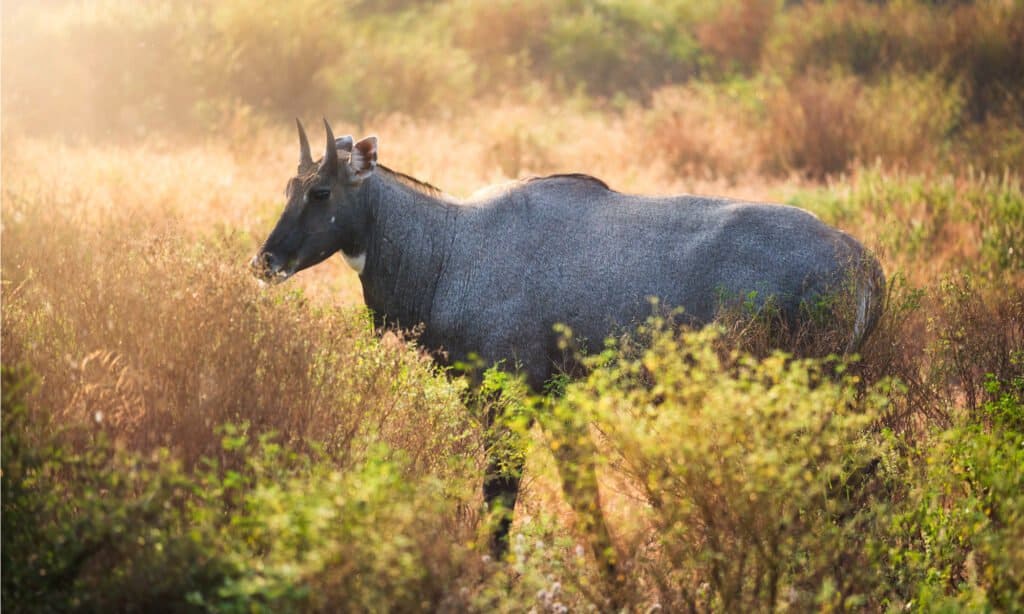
[2,368,472,612]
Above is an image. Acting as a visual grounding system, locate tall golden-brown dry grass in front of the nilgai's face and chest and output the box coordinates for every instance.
[3,134,475,467]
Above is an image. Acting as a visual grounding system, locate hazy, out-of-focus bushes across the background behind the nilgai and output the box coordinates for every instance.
[3,0,1024,178]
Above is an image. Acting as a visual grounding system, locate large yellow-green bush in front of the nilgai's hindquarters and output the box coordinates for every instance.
[555,322,889,611]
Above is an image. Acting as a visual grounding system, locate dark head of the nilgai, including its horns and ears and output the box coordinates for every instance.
[249,125,377,283]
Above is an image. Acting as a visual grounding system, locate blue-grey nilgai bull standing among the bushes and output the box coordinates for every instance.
[250,121,885,572]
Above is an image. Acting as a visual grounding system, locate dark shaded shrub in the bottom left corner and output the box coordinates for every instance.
[2,366,221,612]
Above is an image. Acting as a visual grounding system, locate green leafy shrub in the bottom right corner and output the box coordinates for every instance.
[884,377,1024,612]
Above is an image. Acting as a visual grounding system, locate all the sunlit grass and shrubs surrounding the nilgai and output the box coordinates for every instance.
[2,0,1024,612]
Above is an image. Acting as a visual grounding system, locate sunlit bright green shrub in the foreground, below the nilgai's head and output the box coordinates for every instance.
[190,438,475,611]
